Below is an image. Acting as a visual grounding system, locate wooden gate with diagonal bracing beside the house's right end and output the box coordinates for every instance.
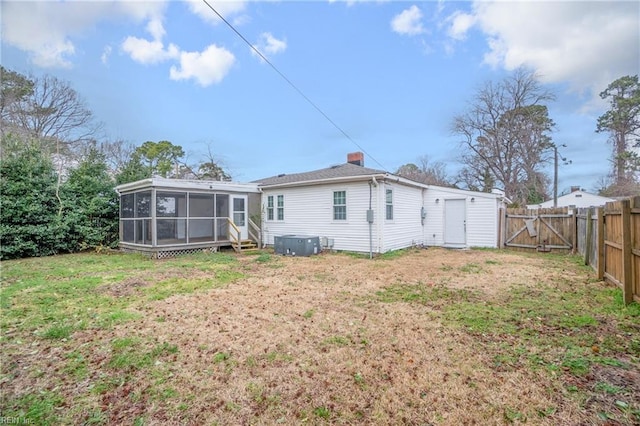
[503,207,575,251]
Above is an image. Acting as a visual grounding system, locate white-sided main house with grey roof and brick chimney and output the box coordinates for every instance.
[255,153,504,253]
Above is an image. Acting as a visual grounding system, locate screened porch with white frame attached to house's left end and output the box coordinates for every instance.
[116,178,261,257]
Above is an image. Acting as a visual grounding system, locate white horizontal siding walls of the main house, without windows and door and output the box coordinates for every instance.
[263,181,499,253]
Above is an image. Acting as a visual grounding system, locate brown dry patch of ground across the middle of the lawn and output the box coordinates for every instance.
[2,249,636,425]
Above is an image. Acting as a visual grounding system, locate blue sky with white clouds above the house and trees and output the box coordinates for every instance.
[1,1,640,191]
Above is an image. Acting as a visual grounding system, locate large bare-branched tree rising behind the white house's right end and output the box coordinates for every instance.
[452,69,555,204]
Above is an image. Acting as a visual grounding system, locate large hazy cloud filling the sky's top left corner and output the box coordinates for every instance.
[2,0,165,68]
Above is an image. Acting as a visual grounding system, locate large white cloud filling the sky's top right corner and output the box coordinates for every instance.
[448,1,640,96]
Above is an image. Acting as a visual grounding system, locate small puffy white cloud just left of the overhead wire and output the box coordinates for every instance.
[169,44,235,87]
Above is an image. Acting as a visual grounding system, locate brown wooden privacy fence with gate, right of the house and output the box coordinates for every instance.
[500,197,640,304]
